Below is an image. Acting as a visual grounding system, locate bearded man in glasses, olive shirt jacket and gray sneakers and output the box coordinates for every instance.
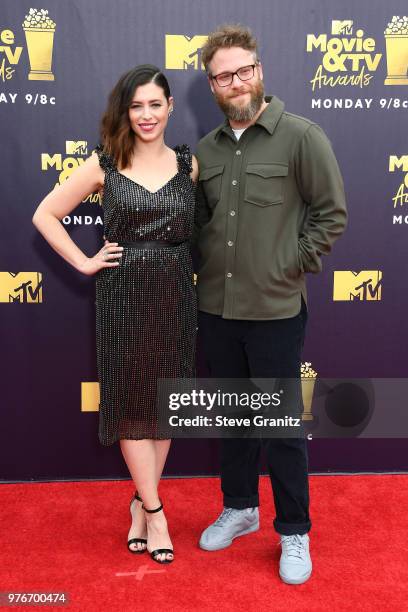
[196,25,346,584]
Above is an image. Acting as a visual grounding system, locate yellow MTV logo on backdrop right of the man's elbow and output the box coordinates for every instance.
[333,270,382,302]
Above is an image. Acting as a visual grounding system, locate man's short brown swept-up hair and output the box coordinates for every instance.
[201,23,258,72]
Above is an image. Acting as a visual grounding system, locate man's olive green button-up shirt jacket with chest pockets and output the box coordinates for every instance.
[195,96,347,320]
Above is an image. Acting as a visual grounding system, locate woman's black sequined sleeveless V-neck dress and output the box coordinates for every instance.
[96,145,196,446]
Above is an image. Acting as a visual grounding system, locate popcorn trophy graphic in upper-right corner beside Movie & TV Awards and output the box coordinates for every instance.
[384,16,408,85]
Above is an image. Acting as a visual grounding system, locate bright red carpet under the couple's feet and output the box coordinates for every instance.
[0,475,408,612]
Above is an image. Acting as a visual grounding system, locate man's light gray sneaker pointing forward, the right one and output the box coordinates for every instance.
[279,533,312,584]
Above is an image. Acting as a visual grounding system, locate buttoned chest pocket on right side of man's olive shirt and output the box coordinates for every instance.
[244,163,289,206]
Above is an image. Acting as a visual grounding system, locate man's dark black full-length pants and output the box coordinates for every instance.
[199,299,311,535]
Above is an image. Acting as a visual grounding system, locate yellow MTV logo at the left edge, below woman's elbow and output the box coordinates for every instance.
[0,272,43,304]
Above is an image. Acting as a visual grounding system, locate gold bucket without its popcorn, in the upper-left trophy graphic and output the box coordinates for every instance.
[23,28,55,81]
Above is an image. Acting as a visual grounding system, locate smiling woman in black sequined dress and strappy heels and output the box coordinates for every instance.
[33,64,198,563]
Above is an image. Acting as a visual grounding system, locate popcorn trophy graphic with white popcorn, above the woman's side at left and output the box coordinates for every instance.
[23,8,55,81]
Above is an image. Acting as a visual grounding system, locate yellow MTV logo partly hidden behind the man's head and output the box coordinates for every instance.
[166,34,207,70]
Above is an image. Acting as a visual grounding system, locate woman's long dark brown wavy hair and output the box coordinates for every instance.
[101,64,171,168]
